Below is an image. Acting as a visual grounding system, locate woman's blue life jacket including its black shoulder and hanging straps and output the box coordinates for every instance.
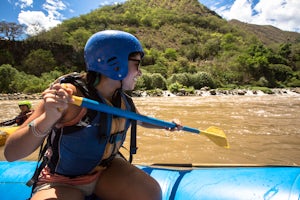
[27,73,137,186]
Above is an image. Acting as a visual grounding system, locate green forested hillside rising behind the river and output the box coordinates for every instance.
[0,0,300,92]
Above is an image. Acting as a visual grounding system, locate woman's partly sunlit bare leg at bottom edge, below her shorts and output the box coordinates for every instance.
[31,186,84,200]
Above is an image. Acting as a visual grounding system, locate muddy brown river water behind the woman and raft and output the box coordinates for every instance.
[0,94,300,166]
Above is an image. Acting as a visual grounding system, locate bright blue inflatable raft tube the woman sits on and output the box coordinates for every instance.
[0,161,300,200]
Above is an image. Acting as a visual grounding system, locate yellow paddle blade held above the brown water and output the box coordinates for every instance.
[200,126,229,148]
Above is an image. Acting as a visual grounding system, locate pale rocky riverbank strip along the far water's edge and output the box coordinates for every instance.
[0,88,300,101]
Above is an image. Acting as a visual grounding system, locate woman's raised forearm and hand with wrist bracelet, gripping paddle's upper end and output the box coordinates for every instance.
[4,84,72,161]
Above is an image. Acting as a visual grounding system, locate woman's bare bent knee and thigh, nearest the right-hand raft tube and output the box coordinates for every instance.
[94,158,162,200]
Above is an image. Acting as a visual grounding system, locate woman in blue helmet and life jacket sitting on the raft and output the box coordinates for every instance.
[4,30,180,200]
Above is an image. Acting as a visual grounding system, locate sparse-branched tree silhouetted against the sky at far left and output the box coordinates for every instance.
[0,21,25,41]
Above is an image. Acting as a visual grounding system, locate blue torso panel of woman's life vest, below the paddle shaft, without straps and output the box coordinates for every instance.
[48,94,131,177]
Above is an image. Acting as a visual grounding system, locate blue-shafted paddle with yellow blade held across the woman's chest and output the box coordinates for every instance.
[72,96,229,148]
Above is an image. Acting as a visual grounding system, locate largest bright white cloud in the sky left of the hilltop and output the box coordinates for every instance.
[18,0,66,36]
